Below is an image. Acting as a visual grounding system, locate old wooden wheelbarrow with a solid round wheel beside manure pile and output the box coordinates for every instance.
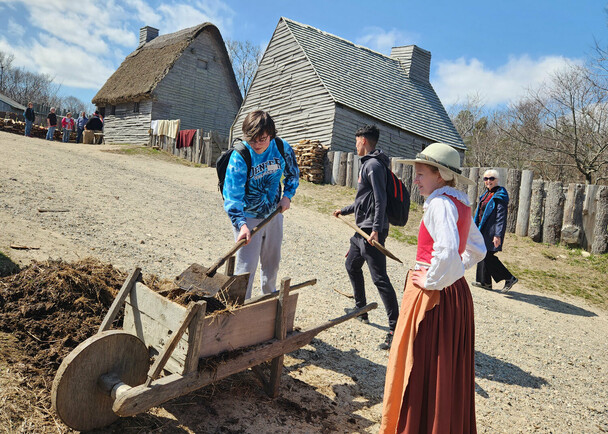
[51,268,377,431]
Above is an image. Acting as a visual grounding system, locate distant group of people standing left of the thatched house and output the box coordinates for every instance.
[23,102,103,143]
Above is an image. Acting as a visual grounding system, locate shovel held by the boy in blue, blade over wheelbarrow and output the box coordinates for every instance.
[176,206,282,298]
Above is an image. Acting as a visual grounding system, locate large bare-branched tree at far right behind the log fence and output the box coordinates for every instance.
[504,65,608,183]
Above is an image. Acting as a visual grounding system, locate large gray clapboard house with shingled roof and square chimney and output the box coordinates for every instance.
[232,18,466,157]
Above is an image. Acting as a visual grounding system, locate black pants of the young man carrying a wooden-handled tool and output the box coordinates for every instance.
[345,229,399,331]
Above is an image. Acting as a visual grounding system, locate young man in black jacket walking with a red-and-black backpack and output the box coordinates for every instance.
[334,125,399,350]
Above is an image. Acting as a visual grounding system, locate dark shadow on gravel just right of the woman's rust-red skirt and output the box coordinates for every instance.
[475,351,549,389]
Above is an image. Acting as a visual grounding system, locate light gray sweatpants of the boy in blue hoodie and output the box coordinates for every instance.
[232,214,283,299]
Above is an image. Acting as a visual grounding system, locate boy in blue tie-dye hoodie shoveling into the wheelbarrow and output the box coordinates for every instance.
[223,110,300,299]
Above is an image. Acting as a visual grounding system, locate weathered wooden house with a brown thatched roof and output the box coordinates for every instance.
[93,23,242,144]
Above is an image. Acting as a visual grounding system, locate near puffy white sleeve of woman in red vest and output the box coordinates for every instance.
[423,196,466,290]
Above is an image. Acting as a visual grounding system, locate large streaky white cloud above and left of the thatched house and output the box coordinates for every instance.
[0,0,236,90]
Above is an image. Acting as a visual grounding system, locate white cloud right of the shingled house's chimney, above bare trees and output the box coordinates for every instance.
[431,55,581,107]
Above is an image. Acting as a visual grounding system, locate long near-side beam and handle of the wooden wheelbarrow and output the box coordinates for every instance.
[112,303,378,417]
